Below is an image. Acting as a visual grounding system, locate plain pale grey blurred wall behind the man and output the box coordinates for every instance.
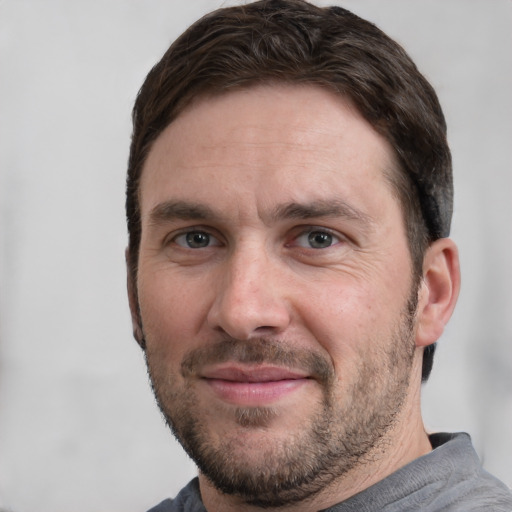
[0,0,512,512]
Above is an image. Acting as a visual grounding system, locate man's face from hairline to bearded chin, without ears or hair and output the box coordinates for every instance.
[132,86,415,506]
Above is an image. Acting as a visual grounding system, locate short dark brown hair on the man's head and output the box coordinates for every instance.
[126,0,453,380]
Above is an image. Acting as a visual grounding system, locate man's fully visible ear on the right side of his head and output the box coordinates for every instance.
[416,238,460,347]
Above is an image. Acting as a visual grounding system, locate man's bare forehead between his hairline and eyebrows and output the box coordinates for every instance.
[139,85,394,218]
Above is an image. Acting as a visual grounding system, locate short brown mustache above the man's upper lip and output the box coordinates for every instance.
[181,337,335,385]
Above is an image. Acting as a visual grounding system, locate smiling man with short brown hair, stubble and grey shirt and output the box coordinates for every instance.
[127,0,512,512]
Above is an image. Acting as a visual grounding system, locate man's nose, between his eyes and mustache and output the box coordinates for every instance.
[207,250,290,340]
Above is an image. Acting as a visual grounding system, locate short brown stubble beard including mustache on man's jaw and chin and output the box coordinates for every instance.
[146,301,416,508]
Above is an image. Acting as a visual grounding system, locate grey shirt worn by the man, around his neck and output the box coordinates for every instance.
[148,433,512,512]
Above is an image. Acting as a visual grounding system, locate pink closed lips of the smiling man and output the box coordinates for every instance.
[201,365,311,407]
